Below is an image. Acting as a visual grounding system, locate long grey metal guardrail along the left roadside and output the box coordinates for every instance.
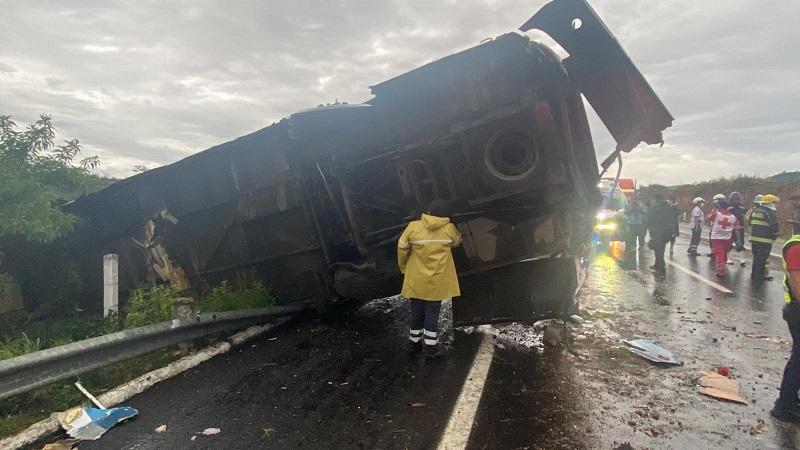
[0,303,312,400]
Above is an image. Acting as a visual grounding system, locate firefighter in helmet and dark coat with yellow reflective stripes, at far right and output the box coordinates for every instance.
[749,194,780,281]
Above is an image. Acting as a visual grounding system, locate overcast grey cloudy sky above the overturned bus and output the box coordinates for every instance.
[0,0,800,184]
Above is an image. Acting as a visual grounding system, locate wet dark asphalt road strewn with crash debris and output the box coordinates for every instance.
[67,234,800,450]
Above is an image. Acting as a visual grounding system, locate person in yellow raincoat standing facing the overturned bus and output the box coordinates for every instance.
[397,199,461,356]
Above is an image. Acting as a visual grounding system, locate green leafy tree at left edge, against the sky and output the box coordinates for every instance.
[0,115,107,242]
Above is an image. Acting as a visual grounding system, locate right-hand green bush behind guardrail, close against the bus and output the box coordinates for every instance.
[200,272,275,312]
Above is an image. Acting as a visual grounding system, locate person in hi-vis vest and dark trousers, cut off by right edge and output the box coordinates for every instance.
[765,191,800,423]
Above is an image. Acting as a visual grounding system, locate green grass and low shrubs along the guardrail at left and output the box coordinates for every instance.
[0,272,275,438]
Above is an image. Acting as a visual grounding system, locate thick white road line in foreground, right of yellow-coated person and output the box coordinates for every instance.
[437,334,494,450]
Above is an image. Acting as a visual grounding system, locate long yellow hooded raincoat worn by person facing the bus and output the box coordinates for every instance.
[397,214,461,301]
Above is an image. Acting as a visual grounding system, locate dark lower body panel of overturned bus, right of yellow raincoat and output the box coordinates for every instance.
[453,258,580,326]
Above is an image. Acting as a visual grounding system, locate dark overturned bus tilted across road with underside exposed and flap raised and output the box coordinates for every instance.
[66,0,672,324]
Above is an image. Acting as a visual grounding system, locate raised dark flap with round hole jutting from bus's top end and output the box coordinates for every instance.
[520,0,673,152]
